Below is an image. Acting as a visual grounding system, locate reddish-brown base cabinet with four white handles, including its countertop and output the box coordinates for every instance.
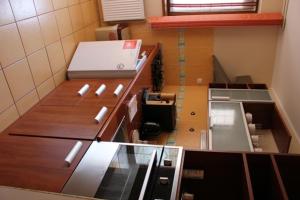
[1,45,158,140]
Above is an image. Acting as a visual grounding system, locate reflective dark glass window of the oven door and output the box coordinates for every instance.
[95,145,162,200]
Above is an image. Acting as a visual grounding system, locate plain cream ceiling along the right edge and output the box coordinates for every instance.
[272,0,300,152]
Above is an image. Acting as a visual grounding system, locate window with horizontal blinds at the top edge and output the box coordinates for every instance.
[166,0,259,15]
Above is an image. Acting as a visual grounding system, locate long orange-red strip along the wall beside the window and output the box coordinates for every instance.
[148,13,283,29]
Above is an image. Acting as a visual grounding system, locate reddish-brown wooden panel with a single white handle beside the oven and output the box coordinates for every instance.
[0,136,91,192]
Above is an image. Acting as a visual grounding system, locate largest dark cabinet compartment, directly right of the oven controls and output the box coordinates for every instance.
[181,150,253,199]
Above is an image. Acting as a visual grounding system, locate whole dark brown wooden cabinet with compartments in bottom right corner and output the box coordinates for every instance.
[177,149,300,200]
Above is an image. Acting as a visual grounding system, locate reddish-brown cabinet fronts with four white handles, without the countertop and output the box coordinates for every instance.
[6,79,131,140]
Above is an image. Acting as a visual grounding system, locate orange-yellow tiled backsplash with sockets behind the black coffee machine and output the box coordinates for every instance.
[148,86,208,149]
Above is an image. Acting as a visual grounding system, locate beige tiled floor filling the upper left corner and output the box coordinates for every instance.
[0,0,100,132]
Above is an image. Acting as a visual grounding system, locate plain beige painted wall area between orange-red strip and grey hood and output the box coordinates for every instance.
[214,26,279,85]
